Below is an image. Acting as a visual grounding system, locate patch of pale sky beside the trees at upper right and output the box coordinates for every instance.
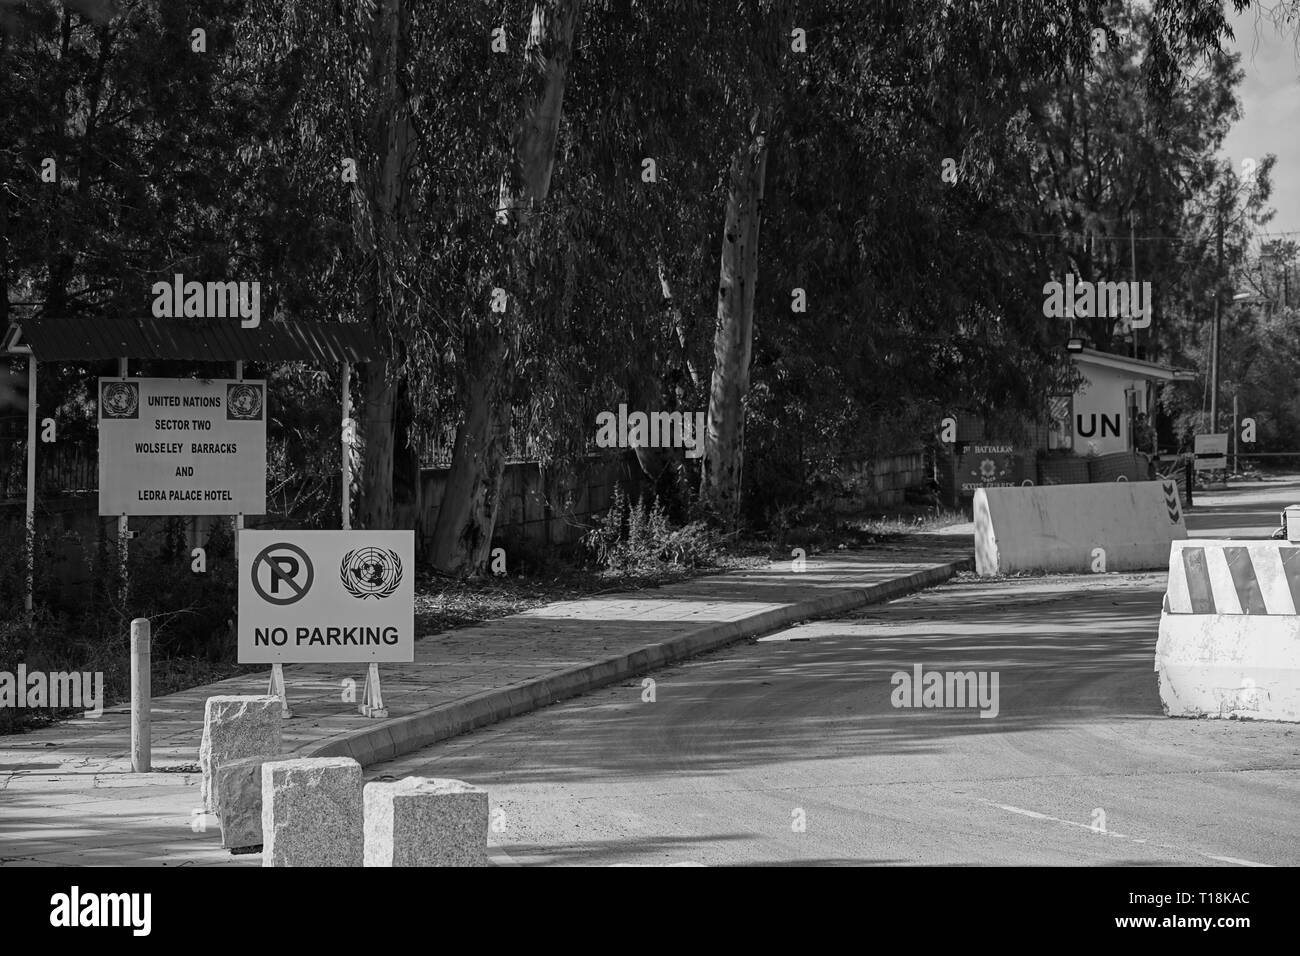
[1223,9,1300,241]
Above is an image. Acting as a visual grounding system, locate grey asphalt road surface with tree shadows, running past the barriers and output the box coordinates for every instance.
[368,485,1300,865]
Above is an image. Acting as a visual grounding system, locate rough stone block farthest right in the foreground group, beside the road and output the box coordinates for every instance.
[365,777,488,866]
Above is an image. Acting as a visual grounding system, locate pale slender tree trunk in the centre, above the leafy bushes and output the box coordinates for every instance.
[701,111,768,527]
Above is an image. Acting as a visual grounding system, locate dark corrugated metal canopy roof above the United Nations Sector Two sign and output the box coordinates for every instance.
[3,316,378,365]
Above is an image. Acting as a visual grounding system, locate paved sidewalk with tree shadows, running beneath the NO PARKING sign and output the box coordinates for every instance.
[0,546,971,865]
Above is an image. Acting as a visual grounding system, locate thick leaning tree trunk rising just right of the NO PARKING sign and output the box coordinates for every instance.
[433,0,581,574]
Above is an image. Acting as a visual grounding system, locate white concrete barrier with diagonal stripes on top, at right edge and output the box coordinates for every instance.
[1156,538,1300,722]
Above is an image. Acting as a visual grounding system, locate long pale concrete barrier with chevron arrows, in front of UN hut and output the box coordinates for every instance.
[974,481,1187,575]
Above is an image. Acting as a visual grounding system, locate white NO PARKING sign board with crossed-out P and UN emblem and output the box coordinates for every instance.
[239,531,415,663]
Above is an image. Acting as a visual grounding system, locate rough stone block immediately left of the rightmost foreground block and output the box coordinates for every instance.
[261,757,365,866]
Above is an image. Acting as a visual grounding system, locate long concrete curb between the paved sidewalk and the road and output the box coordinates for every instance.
[294,558,975,767]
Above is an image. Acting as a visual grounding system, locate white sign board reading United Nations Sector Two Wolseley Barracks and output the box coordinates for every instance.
[99,378,267,515]
